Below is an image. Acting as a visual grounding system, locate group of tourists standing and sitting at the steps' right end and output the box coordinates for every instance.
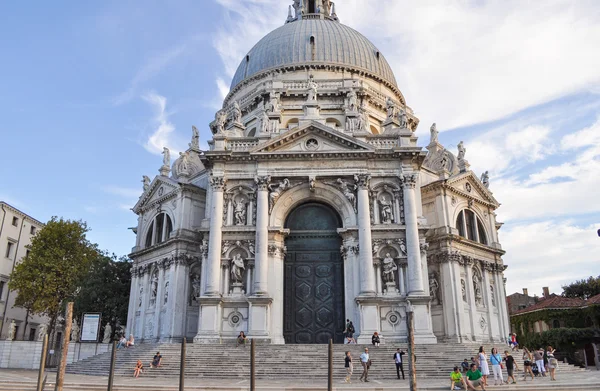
[450,344,558,390]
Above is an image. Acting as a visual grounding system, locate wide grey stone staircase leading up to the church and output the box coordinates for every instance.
[67,343,584,379]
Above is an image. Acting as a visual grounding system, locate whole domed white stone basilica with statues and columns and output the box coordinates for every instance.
[127,0,509,344]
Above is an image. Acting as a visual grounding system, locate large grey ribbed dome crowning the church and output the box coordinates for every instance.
[231,19,398,90]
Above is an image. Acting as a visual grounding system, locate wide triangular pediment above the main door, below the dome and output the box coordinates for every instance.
[250,121,374,154]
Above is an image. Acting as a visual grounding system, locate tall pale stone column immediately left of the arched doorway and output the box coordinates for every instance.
[254,176,271,296]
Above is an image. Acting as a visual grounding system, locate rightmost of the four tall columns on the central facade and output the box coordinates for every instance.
[402,174,426,296]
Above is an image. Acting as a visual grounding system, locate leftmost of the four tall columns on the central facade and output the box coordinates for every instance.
[205,177,226,296]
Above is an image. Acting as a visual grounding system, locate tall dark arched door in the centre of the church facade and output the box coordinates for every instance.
[283,202,344,344]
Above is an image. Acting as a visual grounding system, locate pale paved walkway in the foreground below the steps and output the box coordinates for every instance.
[0,369,600,391]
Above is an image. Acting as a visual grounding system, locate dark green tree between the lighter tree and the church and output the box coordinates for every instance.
[74,253,131,338]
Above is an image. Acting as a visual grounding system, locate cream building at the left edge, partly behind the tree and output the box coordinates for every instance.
[0,201,48,341]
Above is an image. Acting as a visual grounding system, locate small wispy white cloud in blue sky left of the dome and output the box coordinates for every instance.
[142,91,185,157]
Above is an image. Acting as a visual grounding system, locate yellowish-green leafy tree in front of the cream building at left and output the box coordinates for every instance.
[9,217,98,336]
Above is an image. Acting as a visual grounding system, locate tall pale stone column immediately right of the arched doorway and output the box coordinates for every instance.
[356,175,376,296]
